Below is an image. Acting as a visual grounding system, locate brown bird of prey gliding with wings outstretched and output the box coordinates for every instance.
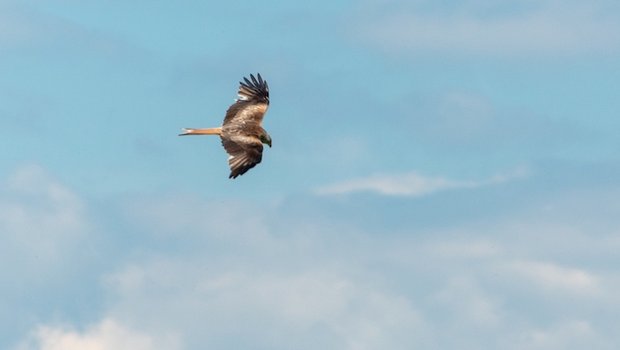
[179,74,271,179]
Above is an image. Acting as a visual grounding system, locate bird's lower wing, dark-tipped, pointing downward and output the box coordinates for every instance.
[222,137,263,179]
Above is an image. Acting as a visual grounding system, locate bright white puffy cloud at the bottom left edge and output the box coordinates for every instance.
[16,319,180,350]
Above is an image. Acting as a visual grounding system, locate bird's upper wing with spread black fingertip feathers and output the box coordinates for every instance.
[223,74,269,129]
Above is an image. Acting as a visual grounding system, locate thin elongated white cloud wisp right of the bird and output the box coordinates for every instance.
[316,168,528,197]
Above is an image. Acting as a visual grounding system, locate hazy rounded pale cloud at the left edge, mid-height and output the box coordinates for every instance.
[0,165,90,269]
